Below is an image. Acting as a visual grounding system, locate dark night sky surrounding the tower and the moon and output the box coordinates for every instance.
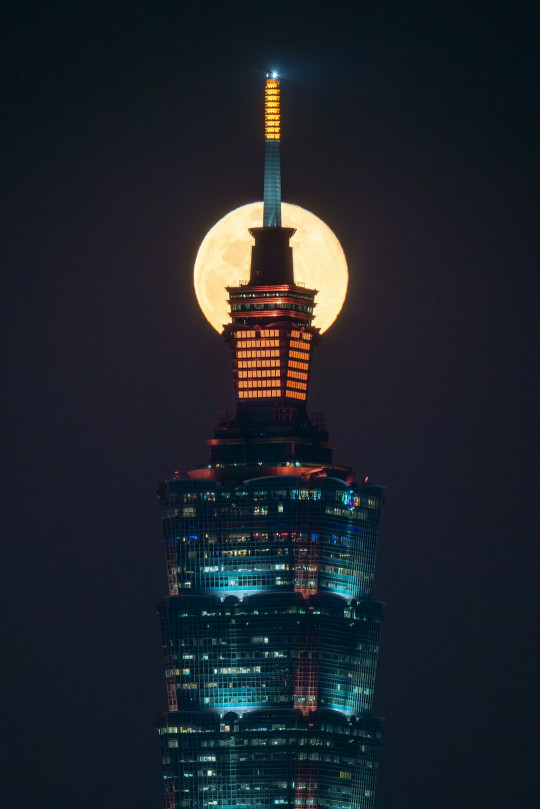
[1,0,539,809]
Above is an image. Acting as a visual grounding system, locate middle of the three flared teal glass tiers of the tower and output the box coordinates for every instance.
[160,592,382,713]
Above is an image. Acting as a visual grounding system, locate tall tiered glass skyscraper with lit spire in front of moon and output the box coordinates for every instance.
[158,74,384,809]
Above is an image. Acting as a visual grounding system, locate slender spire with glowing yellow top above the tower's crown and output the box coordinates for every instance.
[263,73,281,228]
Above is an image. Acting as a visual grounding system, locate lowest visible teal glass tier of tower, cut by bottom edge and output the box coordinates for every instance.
[159,712,382,809]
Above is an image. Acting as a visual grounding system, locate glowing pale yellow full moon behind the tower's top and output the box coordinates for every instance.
[193,202,349,333]
